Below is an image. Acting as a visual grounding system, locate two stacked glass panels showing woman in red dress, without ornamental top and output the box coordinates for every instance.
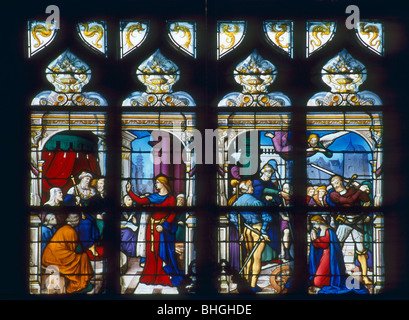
[121,112,196,294]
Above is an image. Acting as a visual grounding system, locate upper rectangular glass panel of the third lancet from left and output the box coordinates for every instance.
[217,113,293,207]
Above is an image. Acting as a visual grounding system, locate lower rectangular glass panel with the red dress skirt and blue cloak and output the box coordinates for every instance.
[120,211,196,295]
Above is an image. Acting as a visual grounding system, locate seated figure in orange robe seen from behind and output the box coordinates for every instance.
[42,214,93,293]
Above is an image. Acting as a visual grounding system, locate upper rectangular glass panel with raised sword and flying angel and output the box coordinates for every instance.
[306,112,383,207]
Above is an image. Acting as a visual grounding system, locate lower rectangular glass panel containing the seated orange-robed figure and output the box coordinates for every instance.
[28,211,107,295]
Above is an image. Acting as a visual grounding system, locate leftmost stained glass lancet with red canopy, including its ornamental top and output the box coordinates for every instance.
[29,63,107,294]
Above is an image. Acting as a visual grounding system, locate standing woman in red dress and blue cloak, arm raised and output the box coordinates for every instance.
[126,176,182,286]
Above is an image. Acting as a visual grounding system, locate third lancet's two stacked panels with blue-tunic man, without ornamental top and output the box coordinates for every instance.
[218,113,294,293]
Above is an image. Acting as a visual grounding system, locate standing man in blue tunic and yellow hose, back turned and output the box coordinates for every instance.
[230,180,271,292]
